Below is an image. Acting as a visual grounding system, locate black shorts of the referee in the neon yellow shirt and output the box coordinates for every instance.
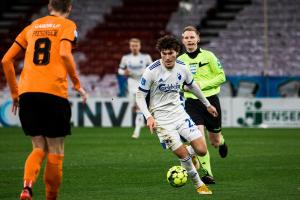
[185,95,222,133]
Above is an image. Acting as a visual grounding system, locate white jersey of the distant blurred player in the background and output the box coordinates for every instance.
[119,53,152,81]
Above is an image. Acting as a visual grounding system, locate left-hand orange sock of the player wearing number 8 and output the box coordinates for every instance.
[24,148,45,188]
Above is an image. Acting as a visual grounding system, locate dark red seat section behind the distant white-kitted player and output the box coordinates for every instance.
[80,0,178,77]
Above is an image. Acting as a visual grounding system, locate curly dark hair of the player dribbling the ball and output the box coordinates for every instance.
[156,35,181,52]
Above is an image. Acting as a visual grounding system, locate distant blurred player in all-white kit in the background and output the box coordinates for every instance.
[118,38,152,139]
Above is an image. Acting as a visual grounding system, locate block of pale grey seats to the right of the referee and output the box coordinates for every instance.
[204,0,300,76]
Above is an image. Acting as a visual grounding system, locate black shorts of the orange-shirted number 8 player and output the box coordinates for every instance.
[19,92,71,138]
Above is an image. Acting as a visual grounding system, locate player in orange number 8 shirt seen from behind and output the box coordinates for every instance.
[2,0,87,200]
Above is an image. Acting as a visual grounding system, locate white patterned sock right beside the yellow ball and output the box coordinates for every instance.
[179,156,204,189]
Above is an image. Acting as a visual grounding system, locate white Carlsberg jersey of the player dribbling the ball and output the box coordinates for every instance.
[139,60,193,122]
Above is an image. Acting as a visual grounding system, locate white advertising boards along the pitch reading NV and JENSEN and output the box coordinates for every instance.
[0,97,300,128]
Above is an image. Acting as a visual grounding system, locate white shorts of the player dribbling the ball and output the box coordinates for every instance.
[156,118,203,151]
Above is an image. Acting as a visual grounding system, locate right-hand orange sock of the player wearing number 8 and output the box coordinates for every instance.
[44,153,64,200]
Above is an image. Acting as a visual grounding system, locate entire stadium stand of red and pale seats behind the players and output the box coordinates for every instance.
[0,0,300,95]
